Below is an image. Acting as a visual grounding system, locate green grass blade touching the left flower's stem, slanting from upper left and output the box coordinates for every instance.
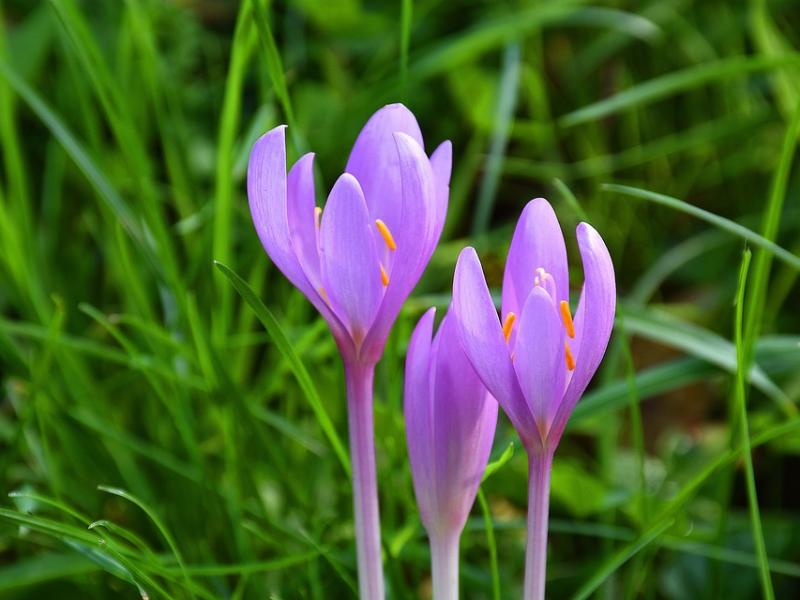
[215,262,350,475]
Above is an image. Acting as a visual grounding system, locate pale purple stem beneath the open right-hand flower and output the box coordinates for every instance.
[523,451,553,600]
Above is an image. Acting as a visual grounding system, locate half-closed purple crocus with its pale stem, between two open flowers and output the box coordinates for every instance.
[405,308,497,600]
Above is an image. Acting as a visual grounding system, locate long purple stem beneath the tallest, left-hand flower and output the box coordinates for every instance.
[345,364,383,600]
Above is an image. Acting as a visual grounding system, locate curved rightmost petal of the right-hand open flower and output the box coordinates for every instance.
[553,223,617,441]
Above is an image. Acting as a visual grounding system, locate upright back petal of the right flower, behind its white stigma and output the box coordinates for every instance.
[502,198,569,319]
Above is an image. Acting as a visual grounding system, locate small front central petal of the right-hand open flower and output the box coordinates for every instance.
[514,287,567,440]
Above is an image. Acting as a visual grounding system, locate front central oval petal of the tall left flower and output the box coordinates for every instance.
[320,173,383,347]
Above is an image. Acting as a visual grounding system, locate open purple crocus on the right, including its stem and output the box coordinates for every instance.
[453,198,616,599]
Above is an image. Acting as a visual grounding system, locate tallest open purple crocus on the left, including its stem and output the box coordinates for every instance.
[247,104,451,600]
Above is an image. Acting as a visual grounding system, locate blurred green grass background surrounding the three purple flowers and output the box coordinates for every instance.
[0,0,800,599]
